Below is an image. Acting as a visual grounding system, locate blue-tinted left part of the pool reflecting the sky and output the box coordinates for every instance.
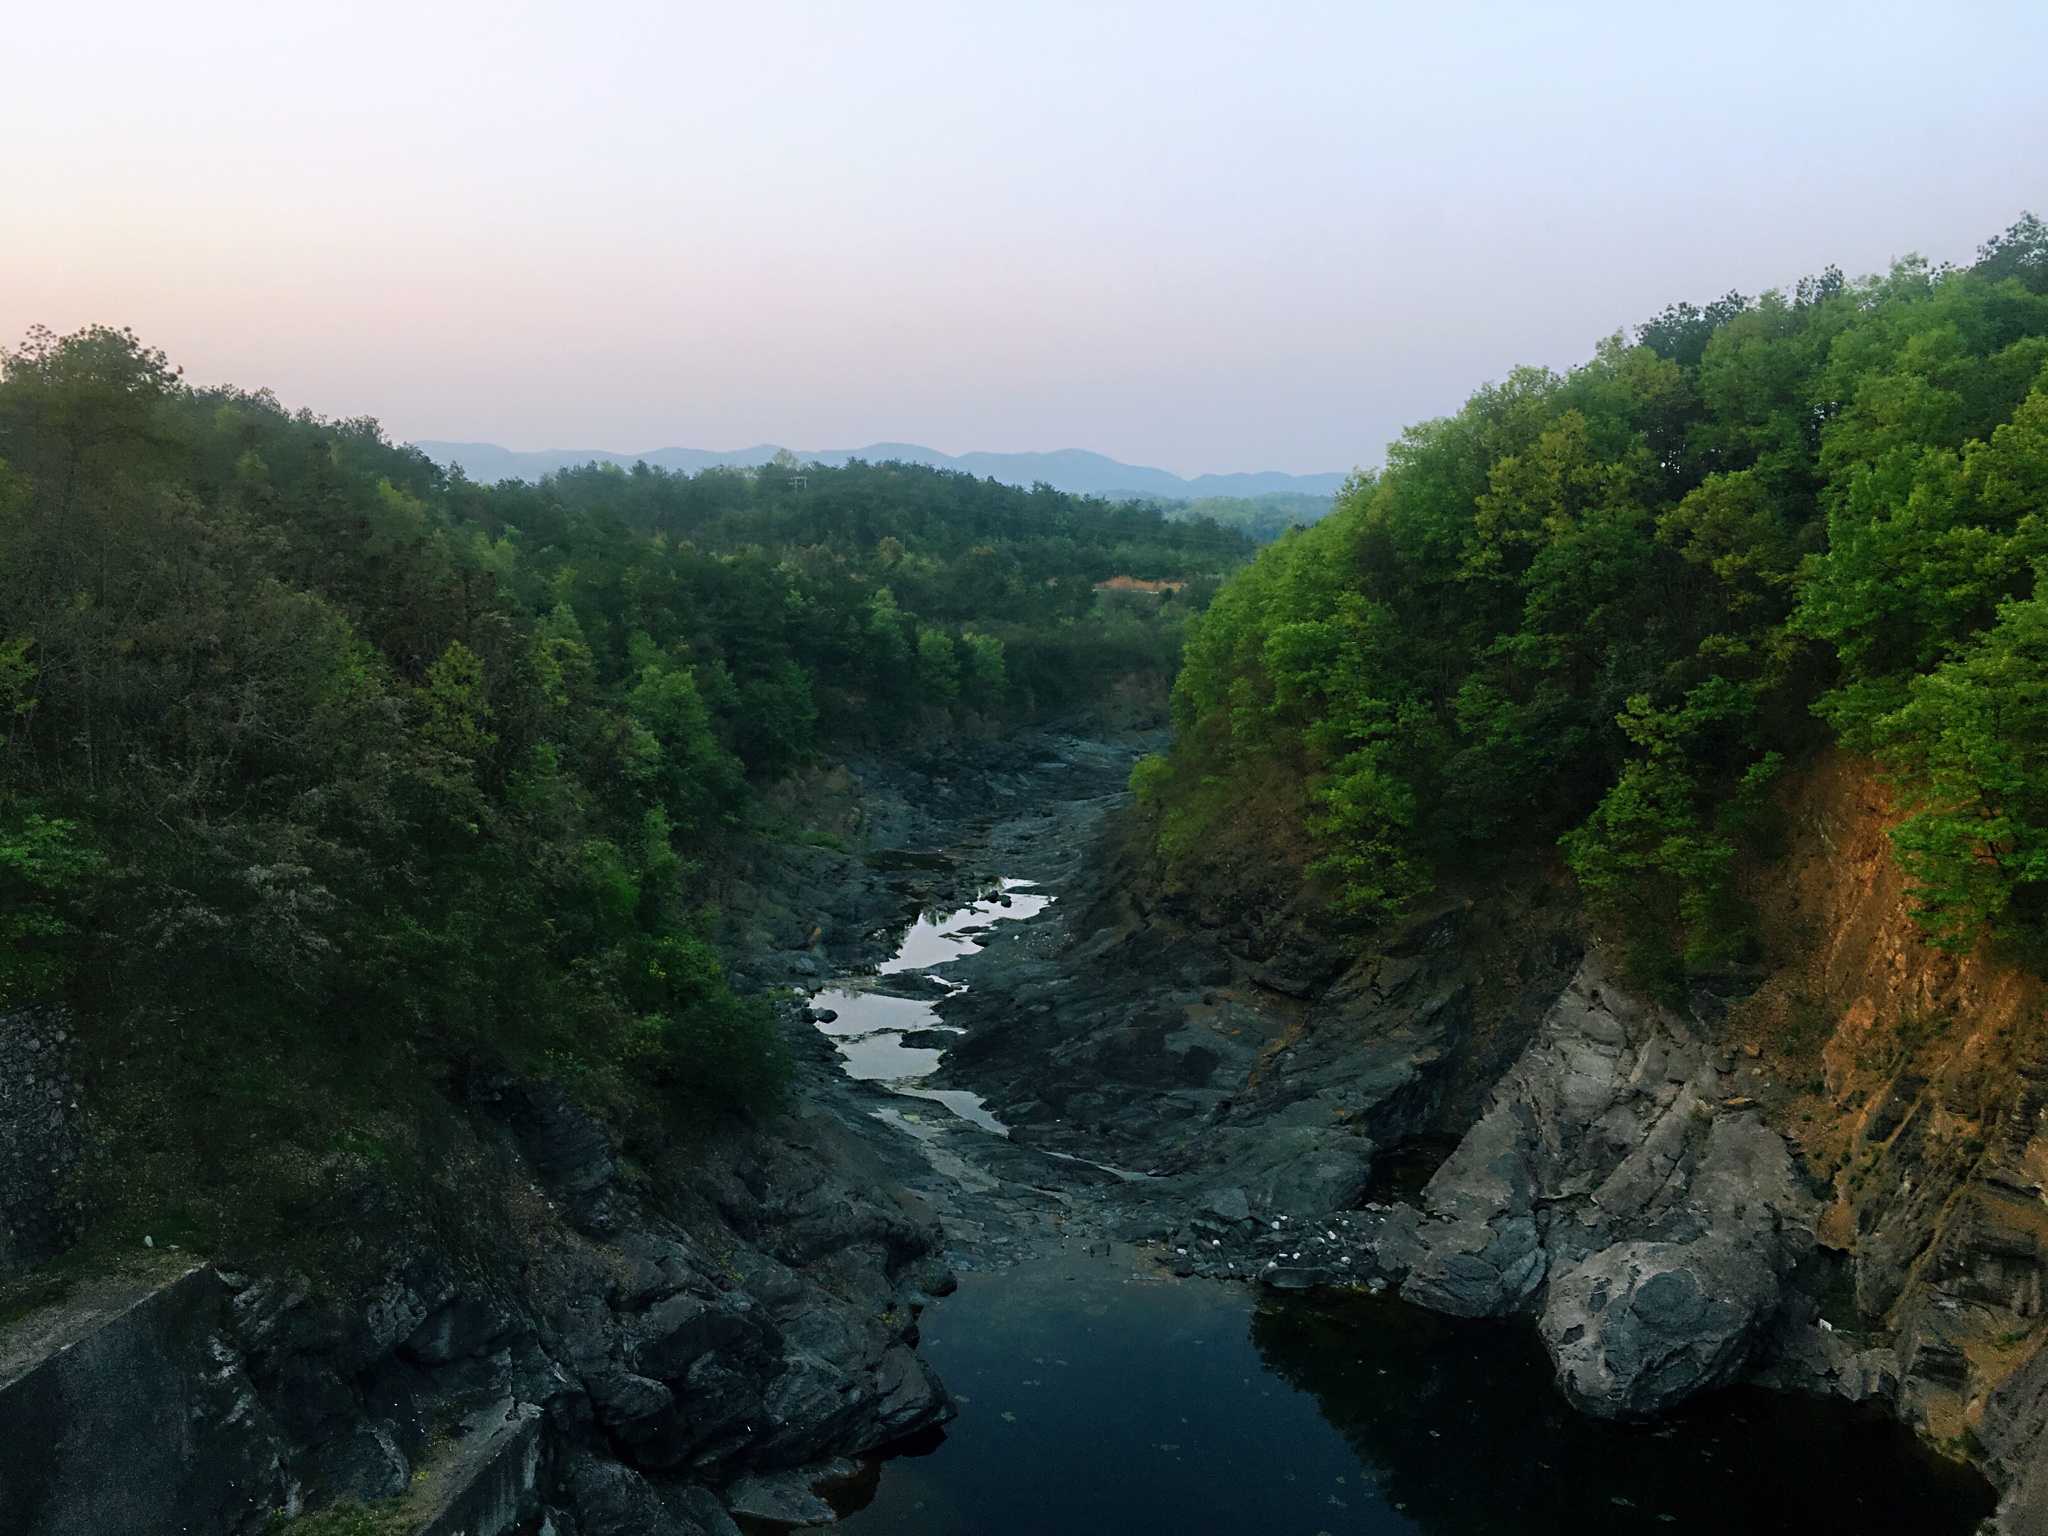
[844,1257,1415,1536]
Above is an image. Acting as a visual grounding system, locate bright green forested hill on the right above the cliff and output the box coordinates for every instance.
[1135,215,2048,979]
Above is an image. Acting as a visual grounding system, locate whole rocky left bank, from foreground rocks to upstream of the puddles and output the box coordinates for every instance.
[0,737,1155,1536]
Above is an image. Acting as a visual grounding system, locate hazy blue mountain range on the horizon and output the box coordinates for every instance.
[412,442,1346,500]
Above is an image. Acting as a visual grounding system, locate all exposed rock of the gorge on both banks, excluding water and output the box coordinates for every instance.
[0,723,2048,1536]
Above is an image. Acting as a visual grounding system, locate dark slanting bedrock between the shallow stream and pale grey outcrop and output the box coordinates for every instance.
[940,884,1577,1219]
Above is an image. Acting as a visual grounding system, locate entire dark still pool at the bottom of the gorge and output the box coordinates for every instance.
[842,1257,1993,1536]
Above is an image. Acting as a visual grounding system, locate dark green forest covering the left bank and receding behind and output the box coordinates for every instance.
[0,330,1251,1163]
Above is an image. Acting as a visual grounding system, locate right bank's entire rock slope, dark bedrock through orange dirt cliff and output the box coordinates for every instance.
[921,741,2048,1532]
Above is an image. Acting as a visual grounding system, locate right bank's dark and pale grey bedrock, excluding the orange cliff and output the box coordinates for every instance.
[942,806,1851,1415]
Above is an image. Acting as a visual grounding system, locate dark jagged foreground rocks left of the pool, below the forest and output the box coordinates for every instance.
[0,1083,952,1536]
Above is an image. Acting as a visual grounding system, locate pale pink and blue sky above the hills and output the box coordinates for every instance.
[0,0,2048,475]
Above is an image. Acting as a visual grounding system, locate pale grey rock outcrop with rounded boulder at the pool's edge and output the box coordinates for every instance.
[1403,958,1821,1415]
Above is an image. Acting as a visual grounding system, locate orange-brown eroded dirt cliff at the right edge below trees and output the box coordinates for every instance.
[1729,754,2048,1530]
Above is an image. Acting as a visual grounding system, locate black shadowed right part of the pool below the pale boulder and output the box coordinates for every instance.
[1251,1296,1995,1536]
